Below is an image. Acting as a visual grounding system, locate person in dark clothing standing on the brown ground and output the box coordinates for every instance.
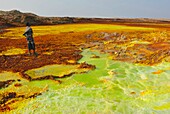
[23,22,37,56]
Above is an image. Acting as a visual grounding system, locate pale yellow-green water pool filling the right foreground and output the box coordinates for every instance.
[8,50,170,114]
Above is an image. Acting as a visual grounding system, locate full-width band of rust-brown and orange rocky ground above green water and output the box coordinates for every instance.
[0,24,170,72]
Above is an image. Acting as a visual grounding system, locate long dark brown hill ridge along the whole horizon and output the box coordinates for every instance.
[0,10,170,28]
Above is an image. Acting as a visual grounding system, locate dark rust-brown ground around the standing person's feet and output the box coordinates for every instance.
[0,33,85,72]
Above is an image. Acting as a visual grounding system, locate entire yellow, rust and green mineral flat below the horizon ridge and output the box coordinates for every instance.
[0,24,170,114]
